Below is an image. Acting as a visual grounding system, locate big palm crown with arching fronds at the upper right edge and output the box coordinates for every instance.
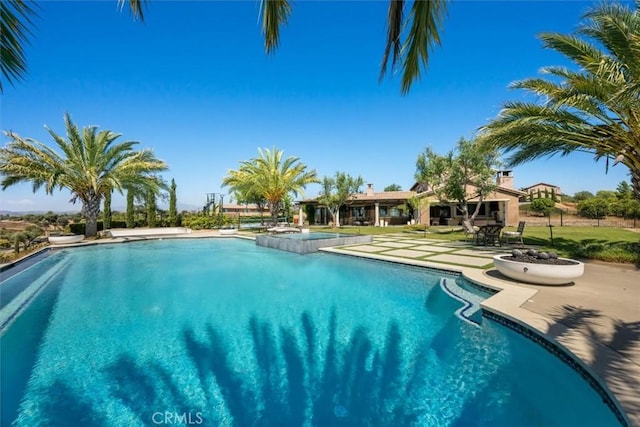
[480,0,640,199]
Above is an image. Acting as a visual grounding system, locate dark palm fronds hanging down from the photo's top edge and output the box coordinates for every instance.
[0,0,447,94]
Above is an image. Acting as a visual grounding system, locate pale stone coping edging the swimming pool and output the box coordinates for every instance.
[0,234,640,426]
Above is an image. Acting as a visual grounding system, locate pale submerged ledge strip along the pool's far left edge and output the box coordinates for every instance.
[0,256,71,335]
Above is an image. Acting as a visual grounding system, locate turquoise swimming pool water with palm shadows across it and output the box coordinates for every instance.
[0,239,619,426]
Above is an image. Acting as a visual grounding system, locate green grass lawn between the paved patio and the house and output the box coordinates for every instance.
[312,226,640,266]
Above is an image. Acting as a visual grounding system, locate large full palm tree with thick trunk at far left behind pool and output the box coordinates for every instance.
[0,114,167,237]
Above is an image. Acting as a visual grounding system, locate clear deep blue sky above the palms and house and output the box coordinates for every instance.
[0,0,628,211]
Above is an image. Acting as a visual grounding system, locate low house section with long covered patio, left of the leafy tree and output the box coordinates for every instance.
[298,184,416,226]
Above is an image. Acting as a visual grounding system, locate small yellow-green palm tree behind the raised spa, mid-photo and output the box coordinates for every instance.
[222,148,320,223]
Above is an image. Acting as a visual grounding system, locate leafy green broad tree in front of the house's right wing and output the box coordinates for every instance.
[415,138,499,221]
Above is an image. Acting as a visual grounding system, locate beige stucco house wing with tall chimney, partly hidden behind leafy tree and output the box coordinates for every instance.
[411,170,526,226]
